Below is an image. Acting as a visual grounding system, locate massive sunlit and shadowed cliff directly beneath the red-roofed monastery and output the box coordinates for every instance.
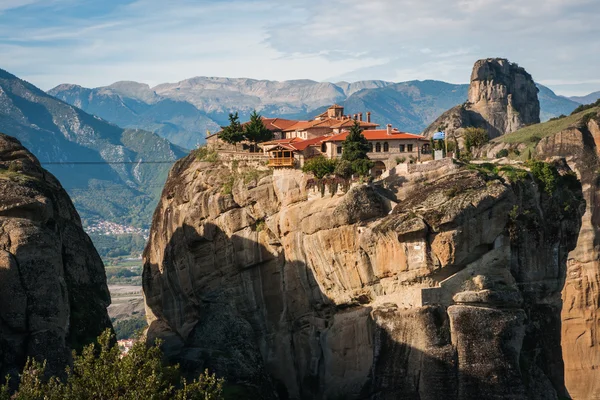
[143,156,583,399]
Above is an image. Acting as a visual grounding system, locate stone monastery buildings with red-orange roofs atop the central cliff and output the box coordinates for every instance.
[206,104,445,178]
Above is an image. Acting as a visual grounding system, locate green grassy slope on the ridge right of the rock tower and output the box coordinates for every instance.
[493,107,600,145]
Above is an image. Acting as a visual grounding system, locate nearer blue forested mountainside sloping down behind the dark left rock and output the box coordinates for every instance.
[0,70,185,225]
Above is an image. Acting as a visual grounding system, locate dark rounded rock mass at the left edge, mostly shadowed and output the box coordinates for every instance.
[0,134,111,381]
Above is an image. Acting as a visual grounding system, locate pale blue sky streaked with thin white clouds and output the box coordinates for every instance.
[0,0,600,95]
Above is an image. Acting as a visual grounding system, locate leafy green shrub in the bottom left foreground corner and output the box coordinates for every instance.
[0,330,223,400]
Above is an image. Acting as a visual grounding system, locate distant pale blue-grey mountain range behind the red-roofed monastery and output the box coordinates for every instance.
[48,77,585,149]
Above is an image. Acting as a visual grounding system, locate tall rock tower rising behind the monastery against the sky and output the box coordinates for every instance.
[424,58,540,138]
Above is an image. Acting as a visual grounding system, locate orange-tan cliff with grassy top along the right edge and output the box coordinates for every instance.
[482,108,600,400]
